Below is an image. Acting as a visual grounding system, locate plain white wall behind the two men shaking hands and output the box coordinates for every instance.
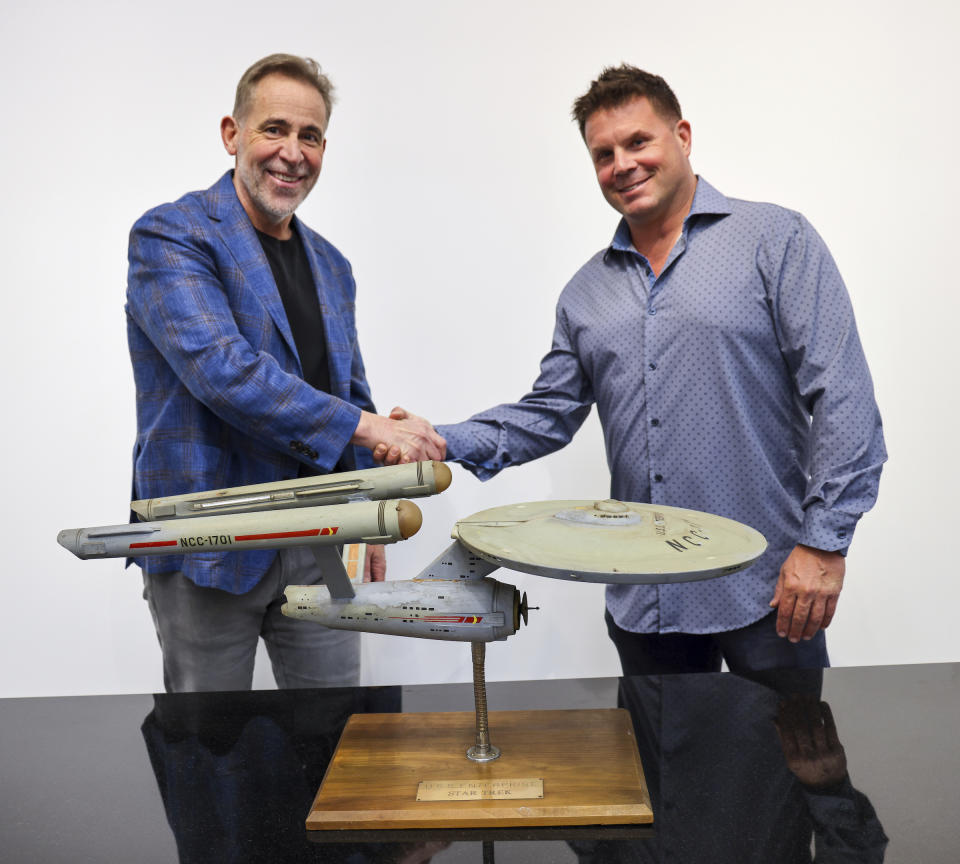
[0,0,960,696]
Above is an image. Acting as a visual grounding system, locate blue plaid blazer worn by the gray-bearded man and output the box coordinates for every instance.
[126,171,375,594]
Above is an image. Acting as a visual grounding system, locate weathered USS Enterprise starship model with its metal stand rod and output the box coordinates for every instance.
[57,462,767,762]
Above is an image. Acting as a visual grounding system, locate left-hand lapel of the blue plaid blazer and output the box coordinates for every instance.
[207,171,300,374]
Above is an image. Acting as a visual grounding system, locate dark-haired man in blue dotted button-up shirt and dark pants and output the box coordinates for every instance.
[380,66,886,674]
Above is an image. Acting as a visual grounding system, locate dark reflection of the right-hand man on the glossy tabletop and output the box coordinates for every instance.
[571,670,887,864]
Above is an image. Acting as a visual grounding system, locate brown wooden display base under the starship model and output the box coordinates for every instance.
[307,708,653,829]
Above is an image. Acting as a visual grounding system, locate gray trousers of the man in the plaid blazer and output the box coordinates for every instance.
[143,548,360,693]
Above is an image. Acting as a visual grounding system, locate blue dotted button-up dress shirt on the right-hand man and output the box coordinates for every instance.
[437,178,886,633]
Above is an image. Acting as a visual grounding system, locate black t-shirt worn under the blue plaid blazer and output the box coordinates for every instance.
[257,231,330,393]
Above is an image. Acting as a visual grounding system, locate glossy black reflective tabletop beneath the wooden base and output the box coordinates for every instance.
[0,664,960,864]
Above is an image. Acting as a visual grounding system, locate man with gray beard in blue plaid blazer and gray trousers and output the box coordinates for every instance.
[126,54,444,691]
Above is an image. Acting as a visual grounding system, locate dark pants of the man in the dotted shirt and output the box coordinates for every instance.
[606,610,830,675]
